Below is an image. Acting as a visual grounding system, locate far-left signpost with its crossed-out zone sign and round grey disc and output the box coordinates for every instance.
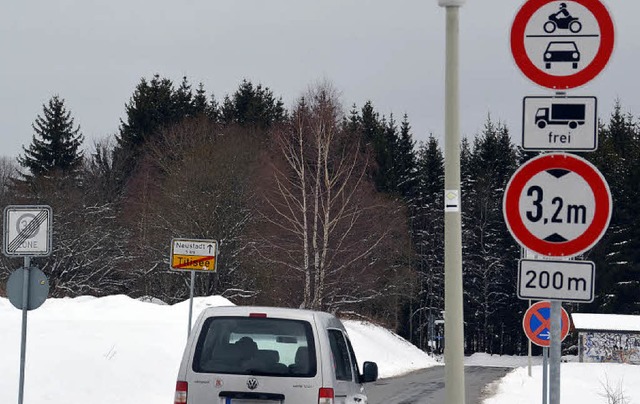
[2,205,53,404]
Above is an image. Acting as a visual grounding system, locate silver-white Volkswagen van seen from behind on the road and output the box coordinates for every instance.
[175,306,378,404]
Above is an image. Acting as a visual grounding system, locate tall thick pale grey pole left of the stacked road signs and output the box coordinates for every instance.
[438,0,465,404]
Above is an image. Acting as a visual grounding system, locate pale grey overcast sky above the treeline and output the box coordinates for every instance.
[0,0,640,156]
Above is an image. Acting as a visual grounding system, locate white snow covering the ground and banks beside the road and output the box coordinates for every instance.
[0,296,640,404]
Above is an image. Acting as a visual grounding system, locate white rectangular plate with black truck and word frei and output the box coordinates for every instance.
[522,97,598,151]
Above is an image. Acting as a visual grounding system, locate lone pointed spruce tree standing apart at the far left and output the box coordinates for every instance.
[18,95,84,182]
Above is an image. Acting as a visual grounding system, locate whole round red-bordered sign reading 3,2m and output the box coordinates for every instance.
[503,153,612,257]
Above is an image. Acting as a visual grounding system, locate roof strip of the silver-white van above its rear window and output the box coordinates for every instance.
[202,306,344,328]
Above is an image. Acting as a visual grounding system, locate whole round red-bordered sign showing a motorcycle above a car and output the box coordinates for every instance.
[511,0,615,89]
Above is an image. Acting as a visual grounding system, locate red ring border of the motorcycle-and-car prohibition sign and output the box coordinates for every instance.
[511,0,615,89]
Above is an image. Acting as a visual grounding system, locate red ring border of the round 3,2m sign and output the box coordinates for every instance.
[502,153,613,257]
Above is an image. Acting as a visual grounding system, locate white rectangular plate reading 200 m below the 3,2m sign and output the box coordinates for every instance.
[518,259,596,303]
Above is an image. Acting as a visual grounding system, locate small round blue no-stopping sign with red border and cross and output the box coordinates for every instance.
[522,301,571,347]
